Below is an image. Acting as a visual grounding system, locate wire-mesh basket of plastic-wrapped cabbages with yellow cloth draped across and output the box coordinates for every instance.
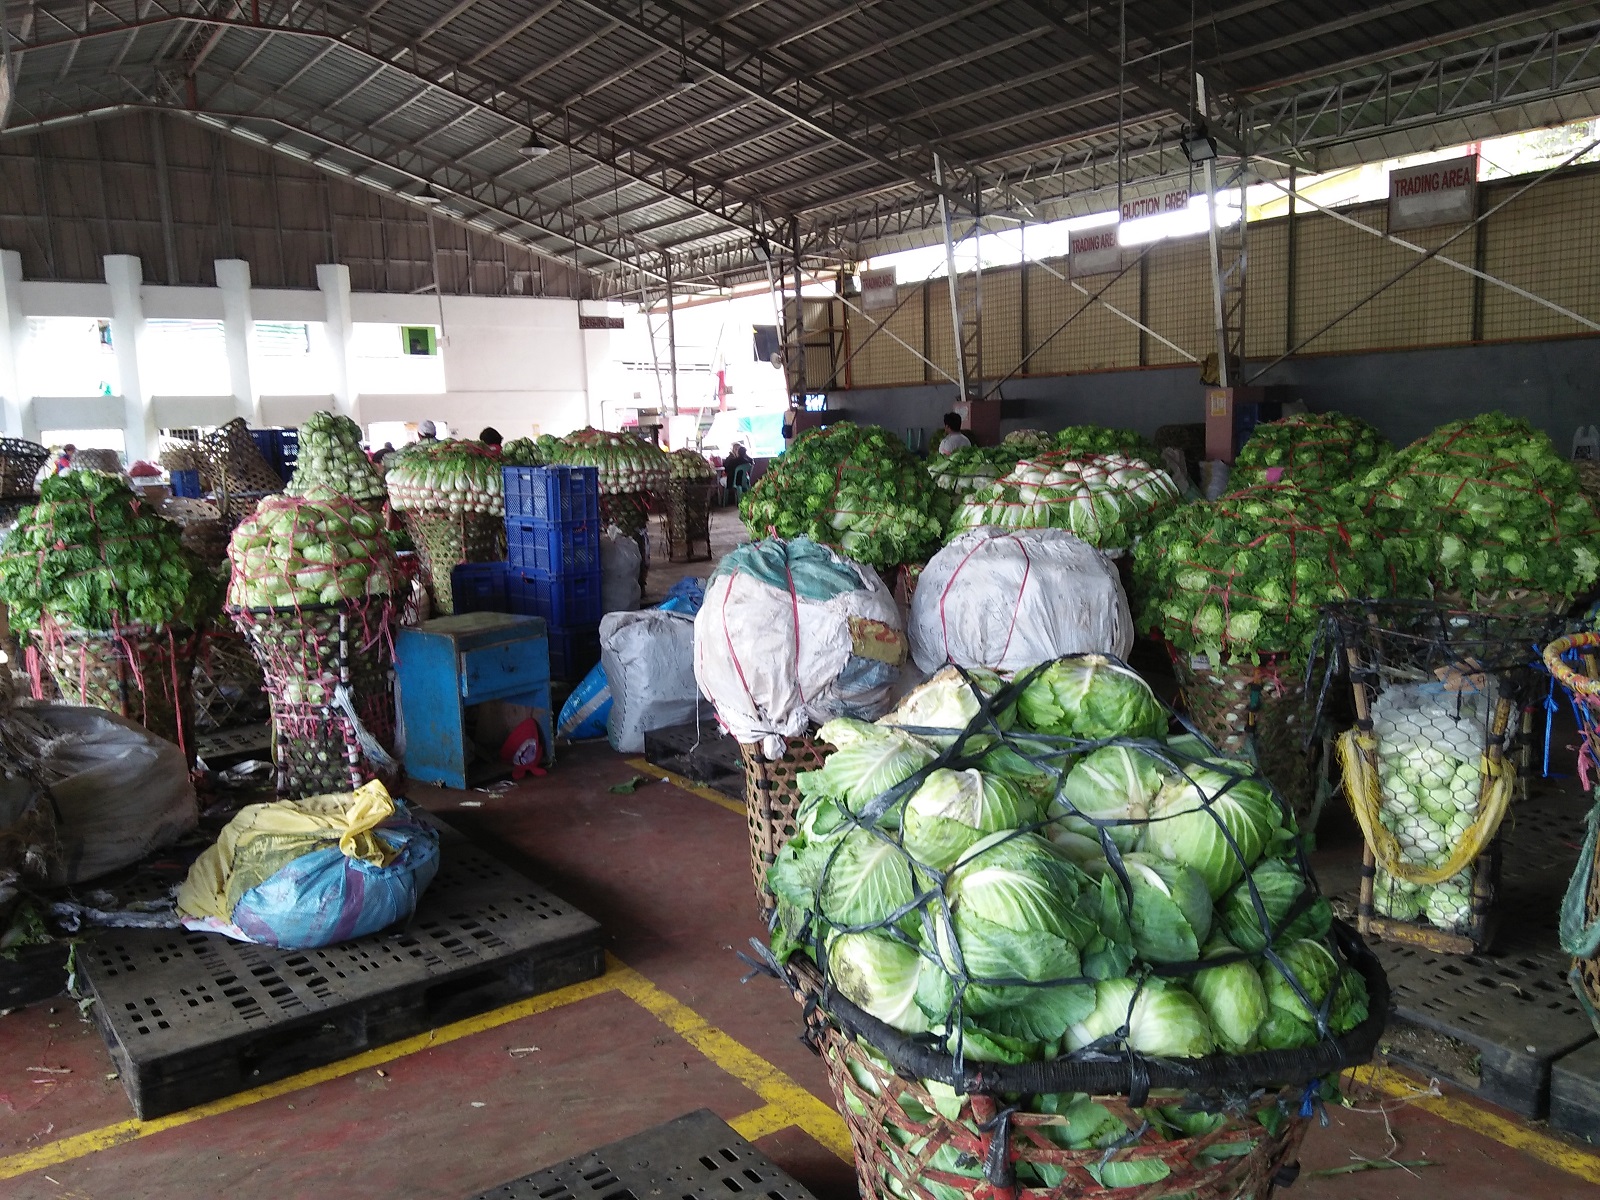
[1326,602,1552,946]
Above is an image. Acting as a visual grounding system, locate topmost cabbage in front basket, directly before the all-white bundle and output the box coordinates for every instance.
[1018,654,1166,739]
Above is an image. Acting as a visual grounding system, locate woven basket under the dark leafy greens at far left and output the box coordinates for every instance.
[29,618,200,763]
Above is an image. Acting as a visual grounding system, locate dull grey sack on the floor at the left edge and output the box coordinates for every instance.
[6,704,200,886]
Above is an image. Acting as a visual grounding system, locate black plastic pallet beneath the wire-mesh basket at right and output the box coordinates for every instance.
[1373,784,1595,1117]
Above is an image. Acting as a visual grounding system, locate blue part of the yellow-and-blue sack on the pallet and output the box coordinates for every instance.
[234,810,438,949]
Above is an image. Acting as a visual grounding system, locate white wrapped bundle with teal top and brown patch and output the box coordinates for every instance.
[694,538,906,758]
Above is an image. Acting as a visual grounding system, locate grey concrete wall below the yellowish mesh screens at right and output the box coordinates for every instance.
[829,338,1600,451]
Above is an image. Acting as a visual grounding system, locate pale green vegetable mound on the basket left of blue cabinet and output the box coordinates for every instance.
[227,490,395,608]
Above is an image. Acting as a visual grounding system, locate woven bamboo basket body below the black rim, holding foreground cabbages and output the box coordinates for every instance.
[818,1022,1310,1200]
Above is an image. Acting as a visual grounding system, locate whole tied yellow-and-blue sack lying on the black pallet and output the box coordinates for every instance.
[178,779,438,950]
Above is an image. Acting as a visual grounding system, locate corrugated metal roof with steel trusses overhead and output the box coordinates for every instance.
[6,0,1600,288]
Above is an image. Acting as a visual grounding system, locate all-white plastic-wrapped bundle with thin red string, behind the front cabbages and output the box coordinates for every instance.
[909,526,1133,672]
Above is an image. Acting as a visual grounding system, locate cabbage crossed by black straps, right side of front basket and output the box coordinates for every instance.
[1141,760,1283,899]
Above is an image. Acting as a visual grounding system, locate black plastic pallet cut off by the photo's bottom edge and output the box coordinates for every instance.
[472,1109,813,1200]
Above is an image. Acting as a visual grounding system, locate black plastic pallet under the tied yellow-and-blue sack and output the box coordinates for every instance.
[78,822,605,1120]
